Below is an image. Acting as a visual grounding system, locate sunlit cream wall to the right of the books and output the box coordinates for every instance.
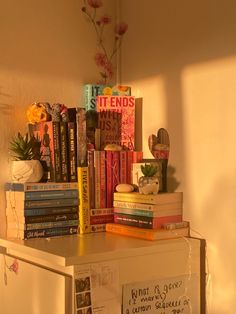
[121,0,236,314]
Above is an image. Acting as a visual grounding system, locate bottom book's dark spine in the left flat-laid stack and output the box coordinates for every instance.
[24,227,78,239]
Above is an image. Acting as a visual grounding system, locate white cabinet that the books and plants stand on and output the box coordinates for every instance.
[0,233,205,314]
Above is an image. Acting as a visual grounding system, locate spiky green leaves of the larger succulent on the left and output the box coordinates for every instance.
[10,132,40,160]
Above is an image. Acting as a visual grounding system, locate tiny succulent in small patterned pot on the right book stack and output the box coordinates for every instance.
[138,163,159,194]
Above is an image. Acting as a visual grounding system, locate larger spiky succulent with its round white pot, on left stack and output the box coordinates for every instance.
[10,132,43,183]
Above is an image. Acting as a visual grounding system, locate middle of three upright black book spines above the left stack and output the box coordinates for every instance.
[60,121,69,182]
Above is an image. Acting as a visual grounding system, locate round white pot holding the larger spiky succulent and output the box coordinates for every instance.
[12,160,43,183]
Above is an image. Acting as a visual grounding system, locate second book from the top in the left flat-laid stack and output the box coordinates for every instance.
[22,189,78,200]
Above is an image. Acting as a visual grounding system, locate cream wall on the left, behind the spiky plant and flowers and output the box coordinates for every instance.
[0,0,116,235]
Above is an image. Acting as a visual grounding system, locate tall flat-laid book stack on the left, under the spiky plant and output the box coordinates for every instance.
[5,182,79,239]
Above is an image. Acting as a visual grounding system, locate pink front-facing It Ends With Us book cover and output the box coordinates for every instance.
[97,95,135,150]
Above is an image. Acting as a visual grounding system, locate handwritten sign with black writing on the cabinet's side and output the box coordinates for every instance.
[122,274,200,314]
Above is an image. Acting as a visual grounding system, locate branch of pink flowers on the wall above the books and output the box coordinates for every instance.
[82,0,128,84]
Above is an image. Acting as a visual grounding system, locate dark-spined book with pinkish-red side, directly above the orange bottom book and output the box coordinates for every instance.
[114,213,183,229]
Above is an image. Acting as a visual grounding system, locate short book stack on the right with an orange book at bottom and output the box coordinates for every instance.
[106,192,189,240]
